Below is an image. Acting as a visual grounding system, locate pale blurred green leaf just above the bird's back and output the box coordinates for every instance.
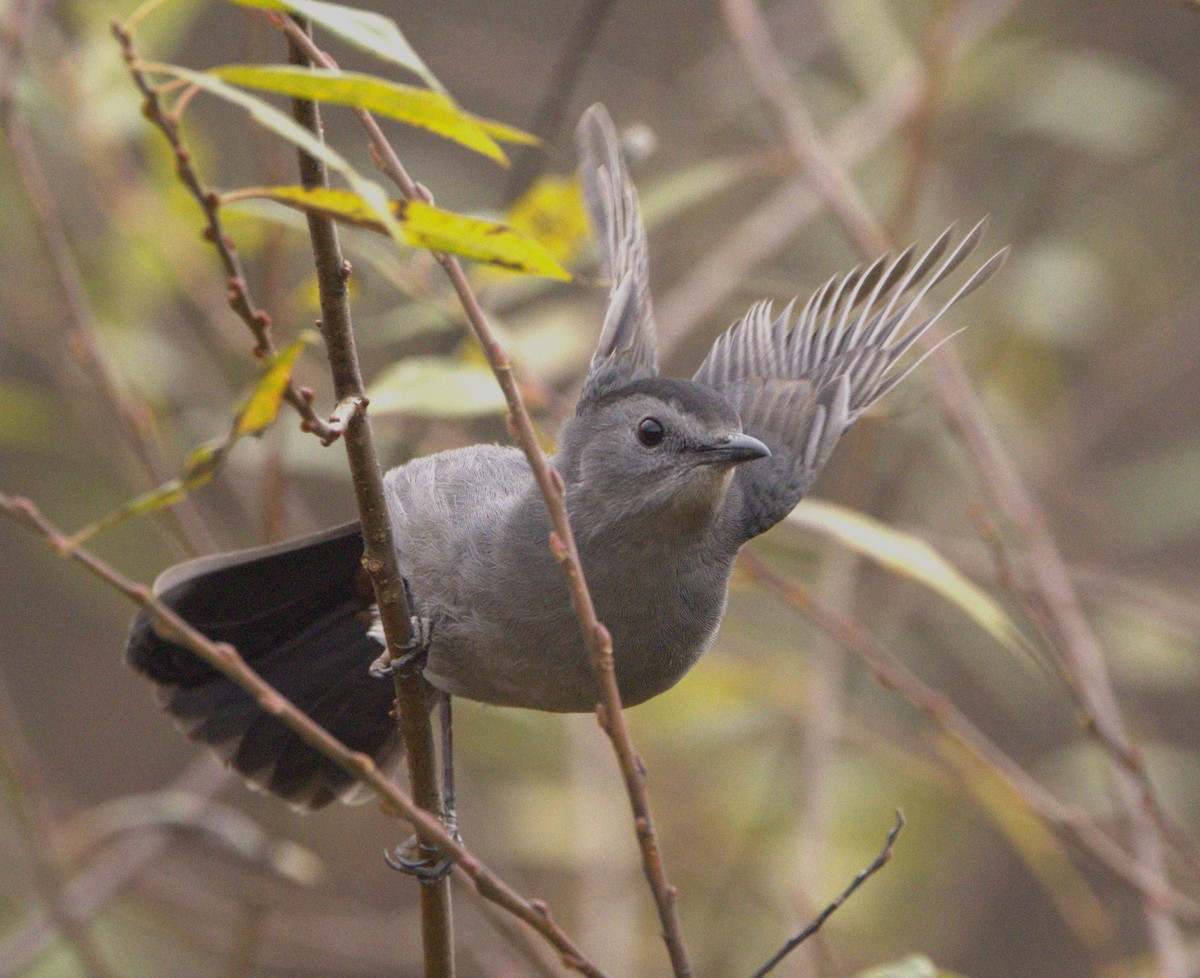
[367,356,508,418]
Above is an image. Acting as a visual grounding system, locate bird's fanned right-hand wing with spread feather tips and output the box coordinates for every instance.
[695,221,1007,545]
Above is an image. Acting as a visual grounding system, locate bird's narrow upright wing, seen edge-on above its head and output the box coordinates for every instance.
[575,104,659,403]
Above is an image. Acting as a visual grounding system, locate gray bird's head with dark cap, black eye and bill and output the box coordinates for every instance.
[558,377,770,540]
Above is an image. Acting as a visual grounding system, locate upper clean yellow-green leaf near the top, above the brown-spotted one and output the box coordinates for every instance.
[209,65,508,166]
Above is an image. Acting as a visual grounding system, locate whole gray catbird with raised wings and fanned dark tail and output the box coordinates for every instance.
[128,106,1003,808]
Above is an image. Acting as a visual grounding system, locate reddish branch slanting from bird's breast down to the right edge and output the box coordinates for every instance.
[738,552,1200,920]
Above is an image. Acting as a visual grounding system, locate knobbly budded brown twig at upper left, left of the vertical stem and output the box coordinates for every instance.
[113,23,338,445]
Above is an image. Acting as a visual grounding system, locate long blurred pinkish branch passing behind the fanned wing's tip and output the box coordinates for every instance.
[722,0,1182,976]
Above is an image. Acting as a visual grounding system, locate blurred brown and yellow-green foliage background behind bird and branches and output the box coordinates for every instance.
[0,0,1200,978]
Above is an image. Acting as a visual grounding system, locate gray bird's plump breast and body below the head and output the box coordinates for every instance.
[385,445,730,712]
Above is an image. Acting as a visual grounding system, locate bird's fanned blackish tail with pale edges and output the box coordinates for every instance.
[126,523,401,809]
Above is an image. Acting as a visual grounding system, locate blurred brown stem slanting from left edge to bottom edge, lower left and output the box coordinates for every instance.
[0,677,114,978]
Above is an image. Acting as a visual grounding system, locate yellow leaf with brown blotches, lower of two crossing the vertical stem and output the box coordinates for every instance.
[221,186,571,281]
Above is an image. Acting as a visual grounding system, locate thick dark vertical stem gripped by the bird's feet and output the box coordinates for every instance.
[288,21,454,978]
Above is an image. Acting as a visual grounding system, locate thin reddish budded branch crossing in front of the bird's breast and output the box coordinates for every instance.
[275,17,691,978]
